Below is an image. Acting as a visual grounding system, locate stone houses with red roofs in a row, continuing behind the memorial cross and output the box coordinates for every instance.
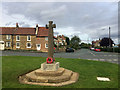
[0,23,66,52]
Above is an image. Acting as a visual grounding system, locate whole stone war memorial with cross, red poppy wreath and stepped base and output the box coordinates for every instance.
[19,21,79,86]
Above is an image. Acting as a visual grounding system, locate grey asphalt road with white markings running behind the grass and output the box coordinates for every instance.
[1,49,120,64]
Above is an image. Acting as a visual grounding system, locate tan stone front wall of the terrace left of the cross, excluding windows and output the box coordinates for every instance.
[0,35,48,52]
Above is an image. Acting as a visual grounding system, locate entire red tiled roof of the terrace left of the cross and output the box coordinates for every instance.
[0,27,48,36]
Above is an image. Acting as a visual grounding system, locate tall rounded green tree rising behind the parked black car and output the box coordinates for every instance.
[70,36,81,50]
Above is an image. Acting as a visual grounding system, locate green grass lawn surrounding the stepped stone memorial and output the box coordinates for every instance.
[2,56,118,88]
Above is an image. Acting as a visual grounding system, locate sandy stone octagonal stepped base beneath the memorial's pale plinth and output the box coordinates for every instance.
[19,62,79,86]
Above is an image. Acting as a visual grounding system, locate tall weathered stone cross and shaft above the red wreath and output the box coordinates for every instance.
[46,21,56,58]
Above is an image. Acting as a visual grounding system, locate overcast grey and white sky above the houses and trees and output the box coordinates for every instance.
[0,0,118,44]
